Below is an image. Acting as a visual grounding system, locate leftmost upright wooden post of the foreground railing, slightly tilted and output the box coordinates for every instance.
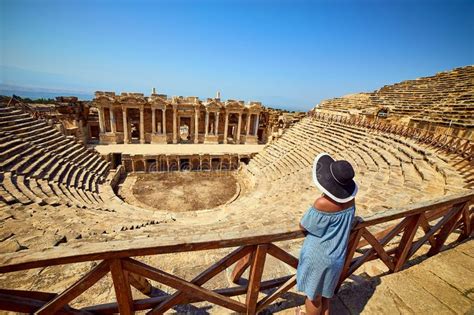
[110,259,133,315]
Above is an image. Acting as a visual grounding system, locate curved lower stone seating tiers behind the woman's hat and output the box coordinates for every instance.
[247,118,469,212]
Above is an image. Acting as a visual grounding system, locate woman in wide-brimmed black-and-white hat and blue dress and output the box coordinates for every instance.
[296,153,357,314]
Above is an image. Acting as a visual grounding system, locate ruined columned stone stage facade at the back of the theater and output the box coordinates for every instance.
[90,92,271,144]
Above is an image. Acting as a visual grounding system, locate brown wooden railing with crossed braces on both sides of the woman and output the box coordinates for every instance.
[0,191,474,314]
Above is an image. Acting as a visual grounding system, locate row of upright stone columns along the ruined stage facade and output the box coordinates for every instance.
[99,106,259,143]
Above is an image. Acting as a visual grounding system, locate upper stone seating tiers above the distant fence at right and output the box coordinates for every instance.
[317,66,474,128]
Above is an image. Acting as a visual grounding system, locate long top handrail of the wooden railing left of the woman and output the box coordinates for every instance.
[0,228,304,273]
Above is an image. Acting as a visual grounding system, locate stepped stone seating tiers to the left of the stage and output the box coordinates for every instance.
[0,105,109,210]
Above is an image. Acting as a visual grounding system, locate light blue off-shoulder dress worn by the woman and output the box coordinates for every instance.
[296,206,355,300]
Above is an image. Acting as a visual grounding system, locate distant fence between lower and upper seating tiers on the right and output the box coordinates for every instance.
[310,112,474,160]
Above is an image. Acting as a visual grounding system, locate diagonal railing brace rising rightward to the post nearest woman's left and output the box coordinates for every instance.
[148,246,253,314]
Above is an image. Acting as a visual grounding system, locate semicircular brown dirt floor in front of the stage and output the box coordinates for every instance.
[132,172,238,212]
